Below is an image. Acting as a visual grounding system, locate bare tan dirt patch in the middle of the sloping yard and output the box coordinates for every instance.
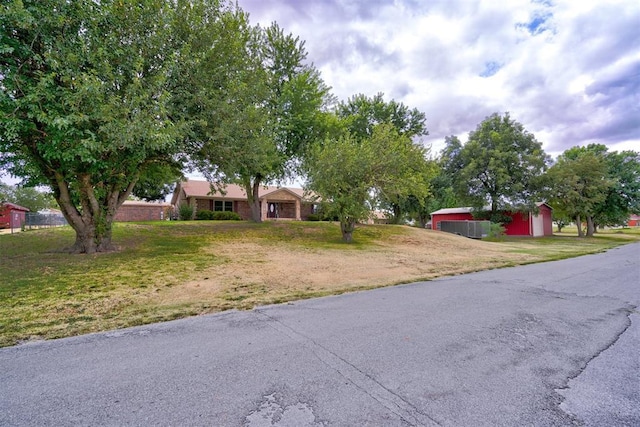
[156,228,535,308]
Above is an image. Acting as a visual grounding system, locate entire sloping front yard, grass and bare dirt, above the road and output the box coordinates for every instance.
[0,222,640,346]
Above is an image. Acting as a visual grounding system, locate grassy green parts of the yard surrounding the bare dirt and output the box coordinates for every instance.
[0,221,640,346]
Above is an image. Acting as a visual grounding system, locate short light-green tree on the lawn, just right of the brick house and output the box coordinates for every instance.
[306,123,426,242]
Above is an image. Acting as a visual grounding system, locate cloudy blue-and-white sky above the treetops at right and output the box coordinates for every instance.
[238,0,640,157]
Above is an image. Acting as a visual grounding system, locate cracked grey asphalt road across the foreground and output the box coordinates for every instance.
[0,244,640,427]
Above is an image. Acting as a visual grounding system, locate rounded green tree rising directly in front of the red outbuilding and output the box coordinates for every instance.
[444,113,549,221]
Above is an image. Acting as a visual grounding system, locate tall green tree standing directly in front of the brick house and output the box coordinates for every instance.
[182,20,330,222]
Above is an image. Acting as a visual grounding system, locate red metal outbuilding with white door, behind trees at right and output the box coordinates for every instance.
[431,203,553,237]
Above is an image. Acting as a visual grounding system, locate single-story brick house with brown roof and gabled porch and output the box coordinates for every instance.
[171,179,314,220]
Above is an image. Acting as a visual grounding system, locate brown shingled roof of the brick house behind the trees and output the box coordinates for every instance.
[171,179,312,204]
